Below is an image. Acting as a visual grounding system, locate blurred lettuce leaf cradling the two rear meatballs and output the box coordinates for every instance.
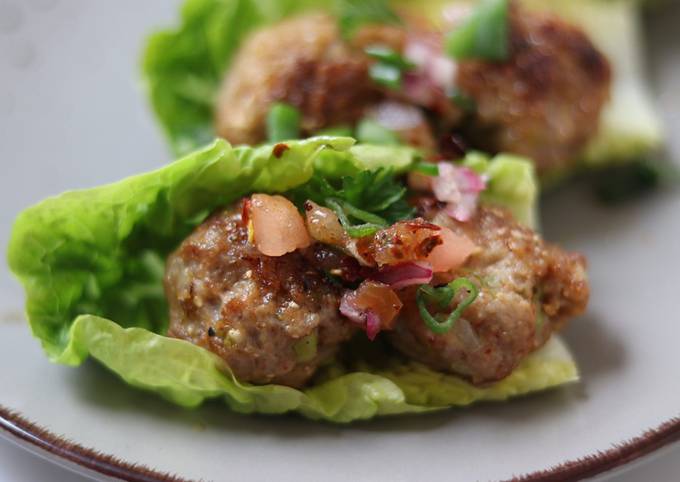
[143,0,663,171]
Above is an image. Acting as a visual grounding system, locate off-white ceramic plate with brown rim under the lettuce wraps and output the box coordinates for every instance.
[0,0,680,482]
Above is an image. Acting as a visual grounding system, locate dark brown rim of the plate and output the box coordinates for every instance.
[0,405,680,482]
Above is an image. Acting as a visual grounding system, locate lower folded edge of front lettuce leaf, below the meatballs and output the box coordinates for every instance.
[61,315,579,423]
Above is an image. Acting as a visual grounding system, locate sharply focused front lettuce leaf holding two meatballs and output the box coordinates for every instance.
[8,137,578,422]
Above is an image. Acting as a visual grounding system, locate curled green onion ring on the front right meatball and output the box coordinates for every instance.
[416,278,479,335]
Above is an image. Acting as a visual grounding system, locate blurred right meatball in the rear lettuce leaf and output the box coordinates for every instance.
[456,4,611,175]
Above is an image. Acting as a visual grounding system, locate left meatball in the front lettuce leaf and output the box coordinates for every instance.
[165,202,354,387]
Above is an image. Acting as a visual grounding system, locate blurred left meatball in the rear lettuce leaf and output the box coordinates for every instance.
[216,14,403,144]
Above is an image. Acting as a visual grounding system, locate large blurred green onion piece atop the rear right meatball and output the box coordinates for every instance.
[446,0,510,62]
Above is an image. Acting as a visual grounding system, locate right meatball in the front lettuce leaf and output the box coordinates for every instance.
[389,202,589,384]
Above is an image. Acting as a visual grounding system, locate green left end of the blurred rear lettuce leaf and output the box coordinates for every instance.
[142,0,333,155]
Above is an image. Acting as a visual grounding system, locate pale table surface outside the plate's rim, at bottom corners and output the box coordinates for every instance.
[0,438,680,482]
